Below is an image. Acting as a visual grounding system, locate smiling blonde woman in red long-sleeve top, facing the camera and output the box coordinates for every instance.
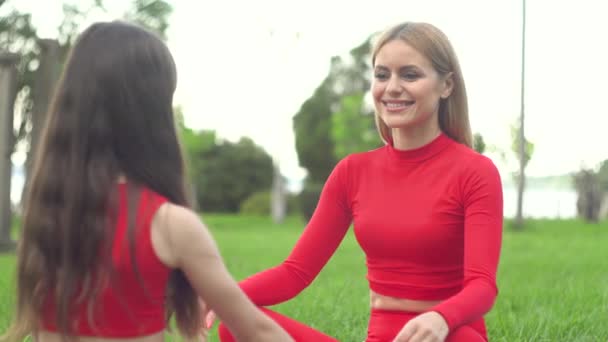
[214,23,503,342]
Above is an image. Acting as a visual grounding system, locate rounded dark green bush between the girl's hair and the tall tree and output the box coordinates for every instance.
[190,138,273,212]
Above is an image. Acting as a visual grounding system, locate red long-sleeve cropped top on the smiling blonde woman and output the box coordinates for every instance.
[241,134,503,329]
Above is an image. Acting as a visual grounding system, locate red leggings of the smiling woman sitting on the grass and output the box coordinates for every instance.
[219,308,488,342]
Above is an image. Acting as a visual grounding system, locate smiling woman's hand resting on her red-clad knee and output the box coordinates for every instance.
[393,311,449,342]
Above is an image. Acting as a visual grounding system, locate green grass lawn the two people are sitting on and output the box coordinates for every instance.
[0,215,608,342]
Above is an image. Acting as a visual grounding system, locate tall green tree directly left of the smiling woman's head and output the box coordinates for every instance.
[293,37,373,219]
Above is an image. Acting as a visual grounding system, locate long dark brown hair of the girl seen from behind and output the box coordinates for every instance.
[4,21,202,341]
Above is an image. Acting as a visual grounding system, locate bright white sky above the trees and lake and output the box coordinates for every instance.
[13,0,608,187]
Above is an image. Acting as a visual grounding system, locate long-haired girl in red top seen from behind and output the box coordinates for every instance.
[3,22,292,342]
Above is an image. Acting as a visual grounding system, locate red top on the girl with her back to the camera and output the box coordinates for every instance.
[42,184,170,338]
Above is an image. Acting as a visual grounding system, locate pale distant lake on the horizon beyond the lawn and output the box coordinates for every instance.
[11,167,576,218]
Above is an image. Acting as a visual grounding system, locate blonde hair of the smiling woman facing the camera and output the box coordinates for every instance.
[372,22,473,147]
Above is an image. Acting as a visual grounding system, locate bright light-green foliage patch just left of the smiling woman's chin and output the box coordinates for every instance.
[331,93,382,160]
